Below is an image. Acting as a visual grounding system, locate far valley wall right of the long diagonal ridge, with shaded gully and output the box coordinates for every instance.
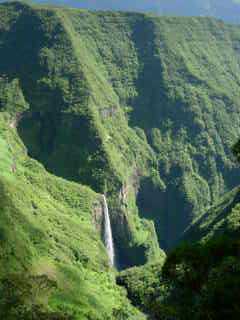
[54,10,240,248]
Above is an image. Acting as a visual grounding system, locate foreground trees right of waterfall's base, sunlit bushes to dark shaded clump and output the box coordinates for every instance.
[117,233,240,320]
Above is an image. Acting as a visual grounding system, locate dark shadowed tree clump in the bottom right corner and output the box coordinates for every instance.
[160,237,240,320]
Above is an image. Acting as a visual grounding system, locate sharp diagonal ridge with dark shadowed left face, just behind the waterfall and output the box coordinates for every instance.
[0,3,163,265]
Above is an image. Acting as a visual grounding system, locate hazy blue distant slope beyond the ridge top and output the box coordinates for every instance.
[3,0,240,23]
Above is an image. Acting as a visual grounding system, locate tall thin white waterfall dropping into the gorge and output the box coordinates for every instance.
[103,195,114,266]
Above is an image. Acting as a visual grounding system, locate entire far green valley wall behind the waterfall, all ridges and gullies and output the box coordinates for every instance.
[0,3,240,258]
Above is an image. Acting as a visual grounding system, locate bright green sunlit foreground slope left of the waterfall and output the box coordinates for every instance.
[0,92,145,320]
